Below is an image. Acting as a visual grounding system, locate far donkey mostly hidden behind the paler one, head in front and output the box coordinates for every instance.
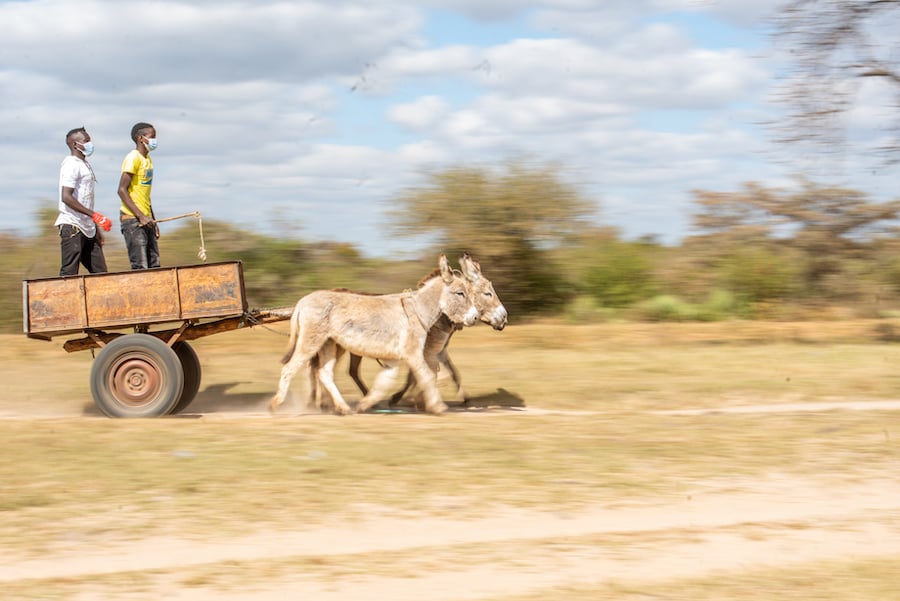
[344,254,508,407]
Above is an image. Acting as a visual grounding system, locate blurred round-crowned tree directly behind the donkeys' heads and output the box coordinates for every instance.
[390,163,593,313]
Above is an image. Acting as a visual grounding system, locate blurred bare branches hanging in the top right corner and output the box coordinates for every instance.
[775,0,900,162]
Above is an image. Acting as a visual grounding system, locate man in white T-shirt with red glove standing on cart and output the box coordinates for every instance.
[54,127,112,276]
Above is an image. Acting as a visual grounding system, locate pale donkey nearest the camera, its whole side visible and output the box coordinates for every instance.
[270,254,478,414]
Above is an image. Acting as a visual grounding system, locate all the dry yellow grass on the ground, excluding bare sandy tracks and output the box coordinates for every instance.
[0,321,900,601]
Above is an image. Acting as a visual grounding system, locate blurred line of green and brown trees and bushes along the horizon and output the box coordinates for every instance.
[0,164,900,332]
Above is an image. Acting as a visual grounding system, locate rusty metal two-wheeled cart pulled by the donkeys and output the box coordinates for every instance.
[22,261,291,417]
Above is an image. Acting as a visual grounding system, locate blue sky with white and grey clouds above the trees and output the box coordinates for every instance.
[0,0,894,258]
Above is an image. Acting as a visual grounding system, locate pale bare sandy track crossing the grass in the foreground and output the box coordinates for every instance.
[0,402,900,601]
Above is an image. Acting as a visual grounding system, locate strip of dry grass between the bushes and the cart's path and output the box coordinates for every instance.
[7,320,900,415]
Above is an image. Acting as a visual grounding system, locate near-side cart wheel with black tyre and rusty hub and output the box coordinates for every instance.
[91,334,184,417]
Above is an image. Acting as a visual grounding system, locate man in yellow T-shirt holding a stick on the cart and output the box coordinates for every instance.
[119,123,159,269]
